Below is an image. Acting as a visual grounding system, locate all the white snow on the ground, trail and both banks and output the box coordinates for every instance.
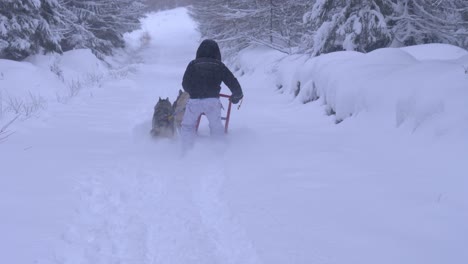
[0,9,468,264]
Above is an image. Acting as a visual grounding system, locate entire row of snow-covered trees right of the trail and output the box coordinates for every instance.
[192,0,468,56]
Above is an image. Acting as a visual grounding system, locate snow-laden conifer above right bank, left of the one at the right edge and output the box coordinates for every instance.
[302,0,391,55]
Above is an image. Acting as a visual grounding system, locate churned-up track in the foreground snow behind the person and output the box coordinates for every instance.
[57,154,258,263]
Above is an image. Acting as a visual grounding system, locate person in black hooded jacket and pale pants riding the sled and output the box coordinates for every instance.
[181,39,244,149]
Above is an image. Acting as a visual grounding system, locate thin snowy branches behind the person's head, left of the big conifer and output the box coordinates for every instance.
[192,0,310,55]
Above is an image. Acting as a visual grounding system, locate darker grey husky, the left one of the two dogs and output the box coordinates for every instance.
[151,97,175,138]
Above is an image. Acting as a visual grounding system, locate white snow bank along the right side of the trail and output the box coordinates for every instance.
[235,45,468,136]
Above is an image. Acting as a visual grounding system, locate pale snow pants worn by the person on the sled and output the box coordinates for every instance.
[180,98,224,149]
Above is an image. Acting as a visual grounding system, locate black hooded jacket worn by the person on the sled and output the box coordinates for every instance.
[182,39,243,99]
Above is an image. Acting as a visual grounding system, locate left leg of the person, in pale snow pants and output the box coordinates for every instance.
[180,99,203,150]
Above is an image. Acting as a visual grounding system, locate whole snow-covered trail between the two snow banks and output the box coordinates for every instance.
[0,9,468,264]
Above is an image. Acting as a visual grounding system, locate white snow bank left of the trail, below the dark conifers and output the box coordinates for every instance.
[0,49,108,121]
